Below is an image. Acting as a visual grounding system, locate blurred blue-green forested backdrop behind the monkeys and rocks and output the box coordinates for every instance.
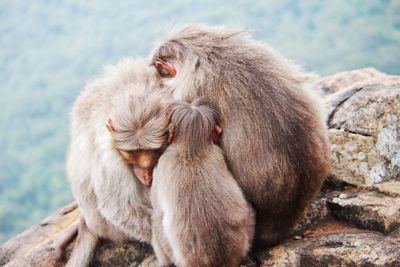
[0,0,400,243]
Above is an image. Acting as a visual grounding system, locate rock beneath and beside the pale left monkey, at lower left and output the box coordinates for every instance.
[0,203,152,267]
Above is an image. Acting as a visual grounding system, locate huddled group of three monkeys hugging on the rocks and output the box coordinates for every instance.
[60,25,329,266]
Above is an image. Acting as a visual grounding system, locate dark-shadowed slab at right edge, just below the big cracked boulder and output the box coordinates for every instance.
[328,191,400,234]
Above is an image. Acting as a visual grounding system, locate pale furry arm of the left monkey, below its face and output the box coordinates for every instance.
[92,151,152,242]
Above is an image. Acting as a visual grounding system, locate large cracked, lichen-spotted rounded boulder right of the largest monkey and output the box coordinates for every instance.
[327,85,400,185]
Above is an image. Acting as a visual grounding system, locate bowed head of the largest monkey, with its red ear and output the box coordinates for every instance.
[152,24,247,101]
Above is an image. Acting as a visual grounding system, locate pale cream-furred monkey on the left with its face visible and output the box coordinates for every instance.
[56,58,168,266]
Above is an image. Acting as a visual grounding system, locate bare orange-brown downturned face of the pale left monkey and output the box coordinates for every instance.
[118,148,165,186]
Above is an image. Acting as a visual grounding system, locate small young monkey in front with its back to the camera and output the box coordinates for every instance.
[150,98,254,267]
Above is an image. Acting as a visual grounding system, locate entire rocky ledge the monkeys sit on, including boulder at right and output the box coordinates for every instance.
[0,68,400,267]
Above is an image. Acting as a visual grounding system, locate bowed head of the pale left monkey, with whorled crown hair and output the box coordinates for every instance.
[106,92,168,186]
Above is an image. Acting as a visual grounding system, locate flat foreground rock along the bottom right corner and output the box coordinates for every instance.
[260,232,400,267]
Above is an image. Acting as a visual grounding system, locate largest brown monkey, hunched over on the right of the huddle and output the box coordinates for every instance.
[152,25,329,249]
